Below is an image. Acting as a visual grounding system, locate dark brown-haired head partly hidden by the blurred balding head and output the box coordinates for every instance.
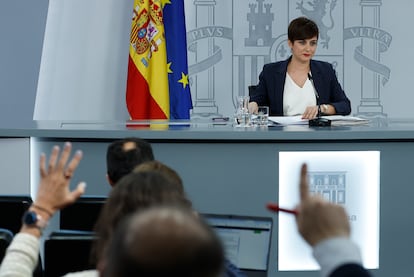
[91,171,192,263]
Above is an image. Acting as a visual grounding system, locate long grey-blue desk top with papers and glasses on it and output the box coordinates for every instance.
[0,119,414,142]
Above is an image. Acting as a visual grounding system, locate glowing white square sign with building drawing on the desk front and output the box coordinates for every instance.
[277,150,381,271]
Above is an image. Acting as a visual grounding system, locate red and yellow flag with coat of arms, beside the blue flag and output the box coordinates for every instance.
[126,0,170,120]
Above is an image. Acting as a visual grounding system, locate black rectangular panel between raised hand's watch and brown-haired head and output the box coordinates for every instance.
[60,196,107,231]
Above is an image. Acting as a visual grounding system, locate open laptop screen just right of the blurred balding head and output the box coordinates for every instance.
[203,214,273,277]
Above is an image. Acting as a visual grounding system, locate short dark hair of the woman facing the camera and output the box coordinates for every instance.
[288,17,319,43]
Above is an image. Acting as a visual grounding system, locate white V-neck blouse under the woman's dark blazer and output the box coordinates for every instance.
[283,73,316,116]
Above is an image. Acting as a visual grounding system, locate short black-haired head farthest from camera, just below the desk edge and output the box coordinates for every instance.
[106,137,154,186]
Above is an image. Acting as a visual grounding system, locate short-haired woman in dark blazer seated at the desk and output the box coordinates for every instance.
[249,17,351,119]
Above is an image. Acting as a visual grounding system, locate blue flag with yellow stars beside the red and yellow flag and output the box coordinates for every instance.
[163,0,193,119]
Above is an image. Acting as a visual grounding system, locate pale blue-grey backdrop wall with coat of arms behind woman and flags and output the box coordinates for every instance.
[0,0,414,120]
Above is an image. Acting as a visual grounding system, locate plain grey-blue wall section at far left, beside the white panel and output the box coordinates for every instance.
[0,0,49,122]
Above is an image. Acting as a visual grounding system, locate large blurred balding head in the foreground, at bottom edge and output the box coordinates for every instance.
[102,206,224,277]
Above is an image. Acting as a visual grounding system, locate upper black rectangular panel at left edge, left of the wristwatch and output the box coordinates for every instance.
[0,195,32,234]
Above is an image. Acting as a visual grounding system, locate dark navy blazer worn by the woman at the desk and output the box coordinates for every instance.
[250,57,351,116]
